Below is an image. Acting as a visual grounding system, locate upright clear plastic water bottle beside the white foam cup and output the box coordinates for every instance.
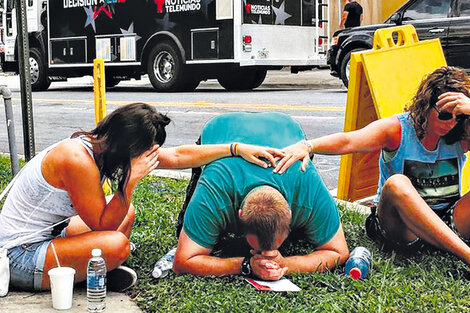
[86,249,106,312]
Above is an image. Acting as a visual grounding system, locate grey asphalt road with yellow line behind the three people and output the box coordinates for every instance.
[0,71,346,189]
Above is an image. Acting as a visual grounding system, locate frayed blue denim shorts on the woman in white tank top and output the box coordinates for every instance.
[8,240,52,291]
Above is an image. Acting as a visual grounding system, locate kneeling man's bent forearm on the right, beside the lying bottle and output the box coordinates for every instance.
[252,225,349,274]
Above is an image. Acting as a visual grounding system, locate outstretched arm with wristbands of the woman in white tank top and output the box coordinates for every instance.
[158,143,284,168]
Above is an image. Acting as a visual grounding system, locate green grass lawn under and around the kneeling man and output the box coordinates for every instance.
[0,158,470,313]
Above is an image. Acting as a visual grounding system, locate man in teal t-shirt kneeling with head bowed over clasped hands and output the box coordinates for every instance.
[173,112,349,280]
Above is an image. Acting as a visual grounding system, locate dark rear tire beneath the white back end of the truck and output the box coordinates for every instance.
[217,68,266,91]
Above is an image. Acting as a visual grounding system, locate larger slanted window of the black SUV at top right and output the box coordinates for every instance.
[402,0,450,21]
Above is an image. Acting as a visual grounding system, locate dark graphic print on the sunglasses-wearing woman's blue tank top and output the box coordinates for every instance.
[403,158,460,206]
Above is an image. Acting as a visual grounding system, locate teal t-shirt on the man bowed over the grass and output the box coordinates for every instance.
[184,112,340,249]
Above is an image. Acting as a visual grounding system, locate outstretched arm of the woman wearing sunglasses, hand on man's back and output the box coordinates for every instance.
[274,116,401,174]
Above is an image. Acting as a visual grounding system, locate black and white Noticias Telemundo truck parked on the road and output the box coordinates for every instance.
[0,0,330,92]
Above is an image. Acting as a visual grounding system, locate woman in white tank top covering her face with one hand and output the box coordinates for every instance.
[0,103,282,290]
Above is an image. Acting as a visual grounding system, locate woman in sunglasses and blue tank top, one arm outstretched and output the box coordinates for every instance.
[275,67,470,265]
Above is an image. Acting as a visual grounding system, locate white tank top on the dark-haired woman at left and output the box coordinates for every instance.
[0,136,93,247]
